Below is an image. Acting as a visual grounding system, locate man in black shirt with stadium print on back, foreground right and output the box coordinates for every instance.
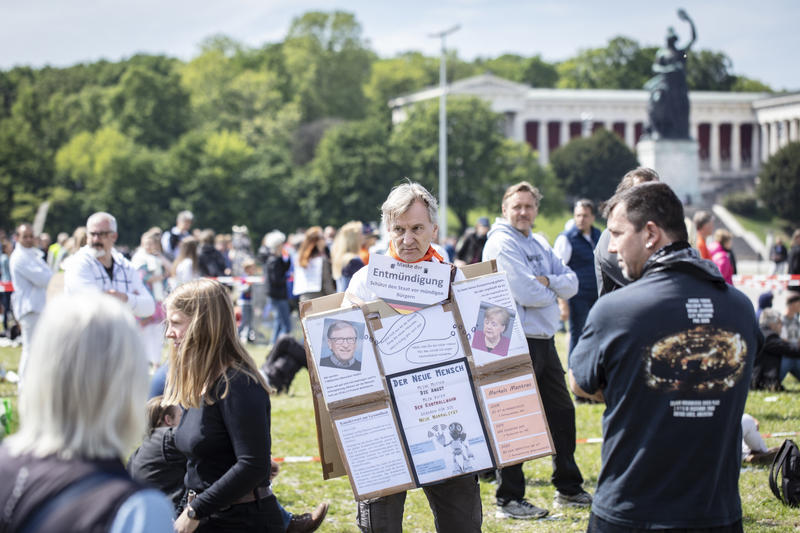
[569,183,762,532]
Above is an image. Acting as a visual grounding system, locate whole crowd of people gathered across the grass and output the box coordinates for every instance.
[0,168,800,532]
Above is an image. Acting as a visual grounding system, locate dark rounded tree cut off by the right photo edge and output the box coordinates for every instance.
[756,142,800,226]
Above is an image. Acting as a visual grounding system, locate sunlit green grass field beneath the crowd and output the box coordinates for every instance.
[0,328,800,533]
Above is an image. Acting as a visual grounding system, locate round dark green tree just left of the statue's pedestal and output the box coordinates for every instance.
[550,129,638,202]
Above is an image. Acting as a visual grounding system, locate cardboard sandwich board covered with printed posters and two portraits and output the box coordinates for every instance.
[300,258,554,500]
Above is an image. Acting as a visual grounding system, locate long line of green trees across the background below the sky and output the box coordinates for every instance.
[0,11,769,244]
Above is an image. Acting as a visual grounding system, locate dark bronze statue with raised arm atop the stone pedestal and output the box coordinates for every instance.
[644,9,697,139]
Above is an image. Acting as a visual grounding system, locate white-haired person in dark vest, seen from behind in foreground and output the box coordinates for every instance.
[0,293,172,533]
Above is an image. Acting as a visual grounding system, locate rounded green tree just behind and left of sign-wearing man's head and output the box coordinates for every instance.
[299,119,402,226]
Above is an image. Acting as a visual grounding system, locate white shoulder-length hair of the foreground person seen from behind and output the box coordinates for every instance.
[8,293,148,459]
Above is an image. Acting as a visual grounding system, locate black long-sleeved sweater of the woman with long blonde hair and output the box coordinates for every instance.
[175,370,271,517]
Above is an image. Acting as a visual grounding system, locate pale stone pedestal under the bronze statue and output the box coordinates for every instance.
[636,139,701,205]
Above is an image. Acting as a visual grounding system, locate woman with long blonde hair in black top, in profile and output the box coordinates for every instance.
[164,279,284,533]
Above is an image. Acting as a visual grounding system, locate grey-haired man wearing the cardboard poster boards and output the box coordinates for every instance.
[343,182,482,533]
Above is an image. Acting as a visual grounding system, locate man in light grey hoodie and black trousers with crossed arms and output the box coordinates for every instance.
[483,181,592,518]
